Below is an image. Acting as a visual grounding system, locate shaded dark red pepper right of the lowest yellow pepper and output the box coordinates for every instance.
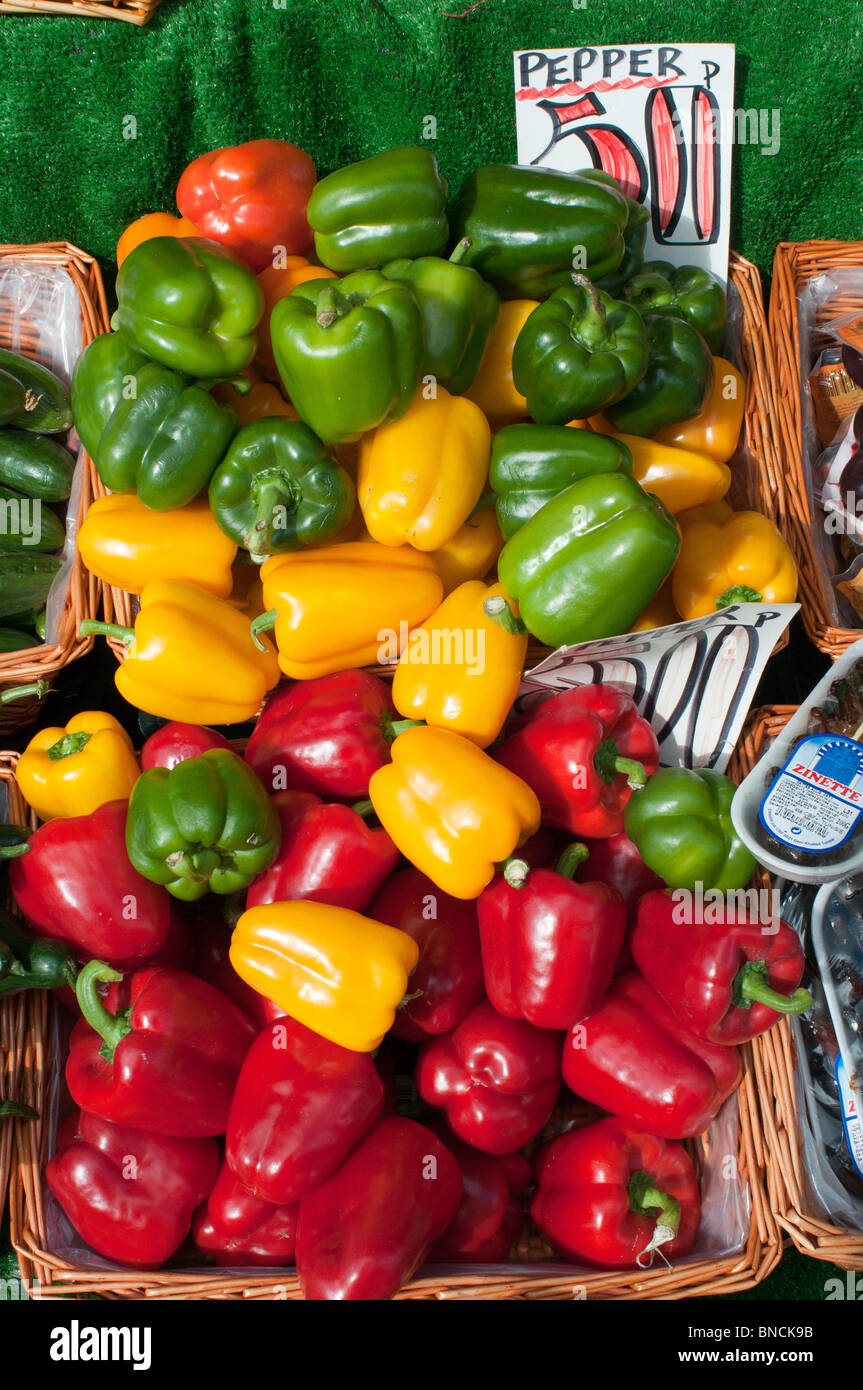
[368,867,482,1043]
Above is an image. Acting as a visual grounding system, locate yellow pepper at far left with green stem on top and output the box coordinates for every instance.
[15,710,140,820]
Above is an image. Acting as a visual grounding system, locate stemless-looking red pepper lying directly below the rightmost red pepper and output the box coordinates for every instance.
[563,970,741,1138]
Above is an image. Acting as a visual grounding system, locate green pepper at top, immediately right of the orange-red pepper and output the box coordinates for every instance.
[306,145,449,275]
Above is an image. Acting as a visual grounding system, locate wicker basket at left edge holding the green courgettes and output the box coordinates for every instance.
[0,242,108,733]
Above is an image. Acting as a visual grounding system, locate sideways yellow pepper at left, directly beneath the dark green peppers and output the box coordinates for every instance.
[78,492,236,599]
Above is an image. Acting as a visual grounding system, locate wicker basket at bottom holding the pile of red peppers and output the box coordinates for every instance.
[0,753,781,1301]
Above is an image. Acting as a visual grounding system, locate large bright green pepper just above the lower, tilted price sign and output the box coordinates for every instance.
[498,471,680,646]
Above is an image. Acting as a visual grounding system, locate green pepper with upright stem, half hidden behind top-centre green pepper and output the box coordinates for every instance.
[384,238,500,396]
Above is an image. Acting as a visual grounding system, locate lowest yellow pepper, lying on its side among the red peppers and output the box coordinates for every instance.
[231,902,420,1052]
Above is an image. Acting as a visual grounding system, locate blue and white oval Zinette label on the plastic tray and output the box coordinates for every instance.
[759,734,863,855]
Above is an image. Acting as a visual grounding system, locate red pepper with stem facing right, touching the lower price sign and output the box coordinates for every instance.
[495,685,659,840]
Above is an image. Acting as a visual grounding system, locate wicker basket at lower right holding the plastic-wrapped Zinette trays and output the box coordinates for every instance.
[730,705,863,1269]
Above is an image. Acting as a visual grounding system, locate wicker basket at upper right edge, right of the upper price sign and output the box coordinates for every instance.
[770,242,863,660]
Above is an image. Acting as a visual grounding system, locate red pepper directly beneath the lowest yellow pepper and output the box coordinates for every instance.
[225,1016,384,1207]
